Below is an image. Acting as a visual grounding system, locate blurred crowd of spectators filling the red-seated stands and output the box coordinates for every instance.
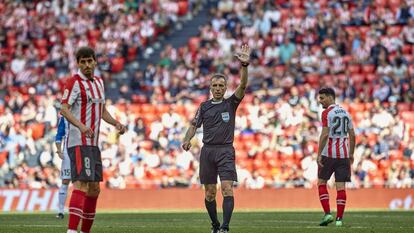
[0,0,414,189]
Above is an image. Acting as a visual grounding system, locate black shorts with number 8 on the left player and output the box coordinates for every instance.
[68,146,102,182]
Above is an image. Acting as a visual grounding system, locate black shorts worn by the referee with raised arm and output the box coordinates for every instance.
[200,145,237,184]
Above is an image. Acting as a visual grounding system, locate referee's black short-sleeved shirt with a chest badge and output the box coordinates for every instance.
[191,94,241,145]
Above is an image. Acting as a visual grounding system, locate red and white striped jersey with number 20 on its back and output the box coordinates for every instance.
[322,104,354,159]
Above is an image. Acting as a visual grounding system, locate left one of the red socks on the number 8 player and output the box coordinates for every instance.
[68,189,85,231]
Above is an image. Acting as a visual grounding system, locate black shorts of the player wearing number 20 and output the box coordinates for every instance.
[318,156,351,182]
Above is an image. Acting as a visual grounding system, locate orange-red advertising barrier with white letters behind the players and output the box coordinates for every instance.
[0,188,414,212]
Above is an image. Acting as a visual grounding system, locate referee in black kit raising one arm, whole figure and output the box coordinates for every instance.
[182,45,250,233]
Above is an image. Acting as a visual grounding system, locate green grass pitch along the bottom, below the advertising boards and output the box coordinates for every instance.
[0,211,414,233]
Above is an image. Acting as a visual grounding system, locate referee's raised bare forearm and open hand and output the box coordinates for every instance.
[234,44,250,99]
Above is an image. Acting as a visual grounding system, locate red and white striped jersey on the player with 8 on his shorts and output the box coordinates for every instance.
[62,72,105,148]
